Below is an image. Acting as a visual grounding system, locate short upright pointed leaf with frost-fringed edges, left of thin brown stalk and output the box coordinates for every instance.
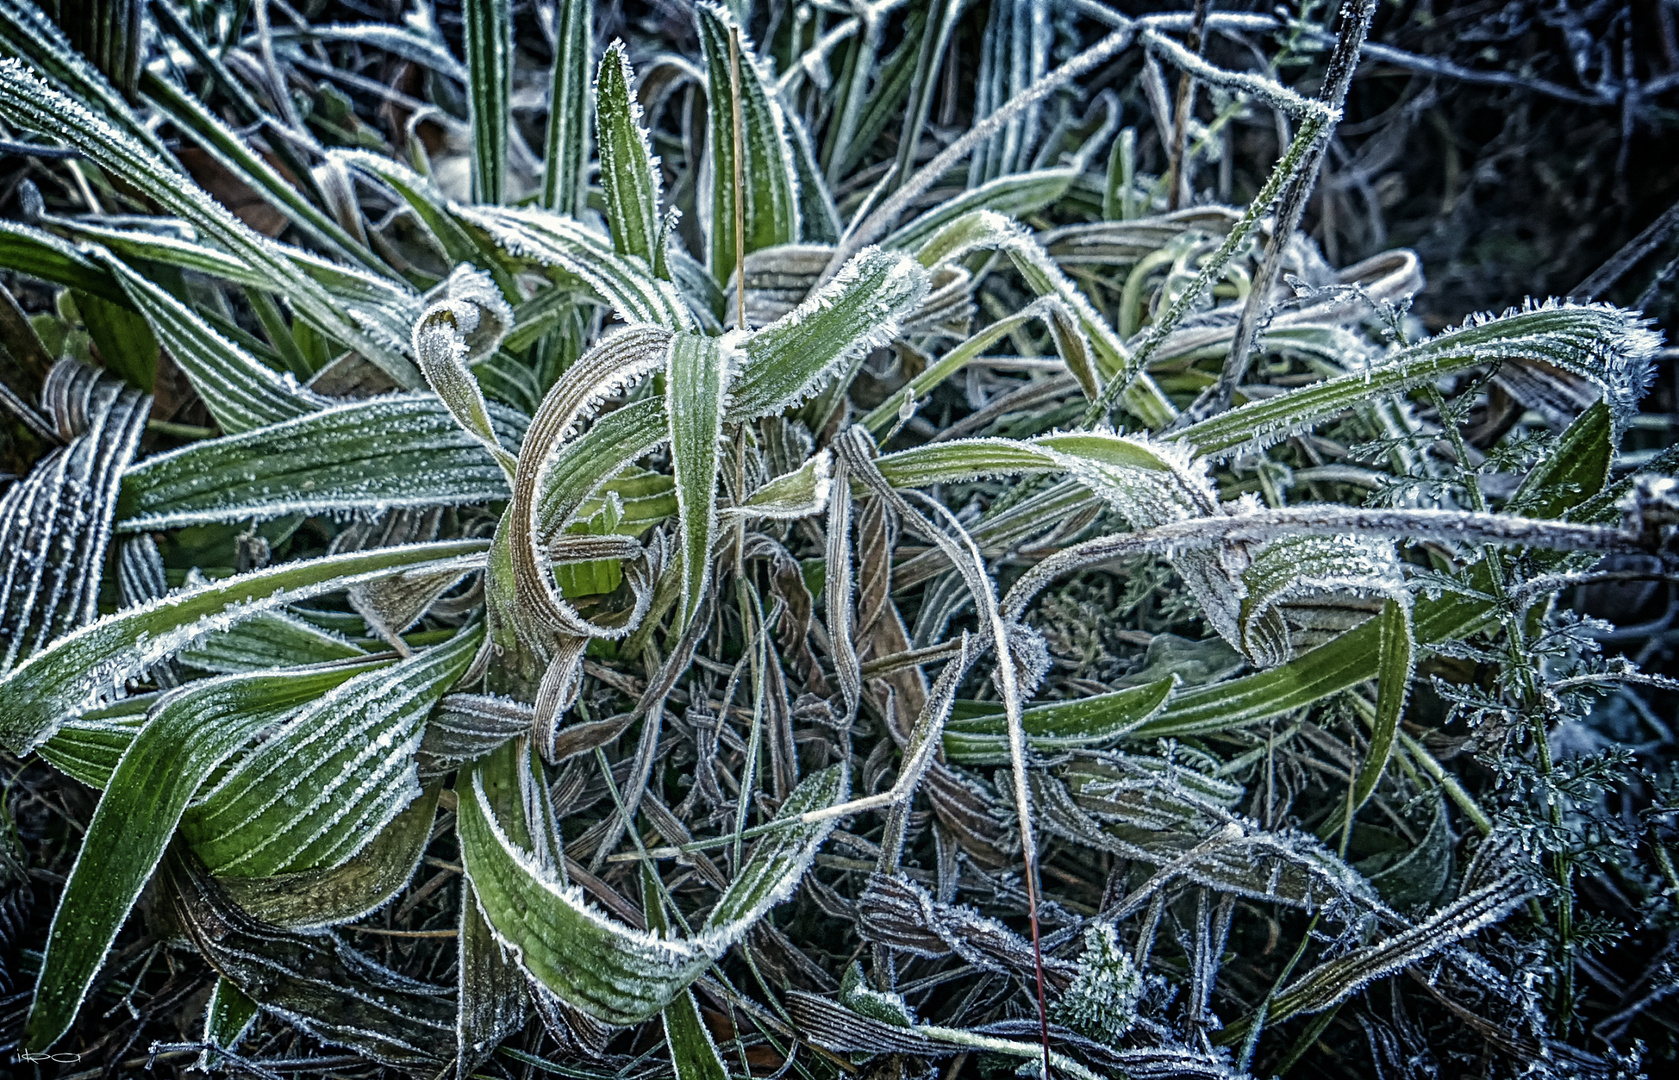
[594,42,660,267]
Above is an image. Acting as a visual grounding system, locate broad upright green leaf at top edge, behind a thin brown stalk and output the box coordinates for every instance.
[693,3,799,282]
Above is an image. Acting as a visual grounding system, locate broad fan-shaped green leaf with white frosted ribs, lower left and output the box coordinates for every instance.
[181,627,482,877]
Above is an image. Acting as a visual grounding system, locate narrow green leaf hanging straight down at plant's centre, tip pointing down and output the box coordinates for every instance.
[665,334,737,628]
